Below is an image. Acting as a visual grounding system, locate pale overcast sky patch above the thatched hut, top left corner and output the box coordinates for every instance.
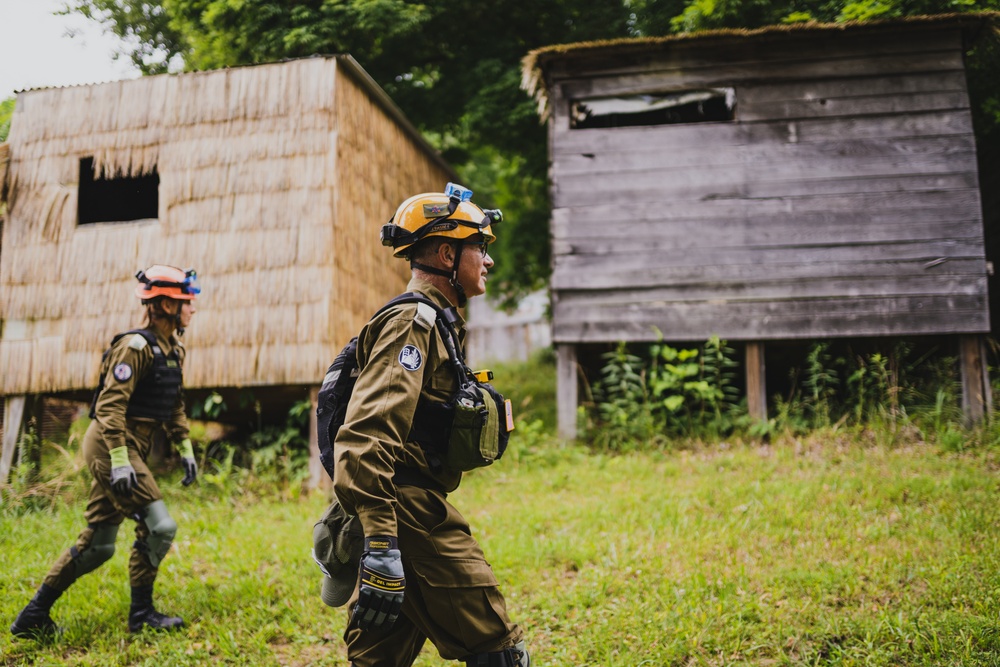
[0,0,139,100]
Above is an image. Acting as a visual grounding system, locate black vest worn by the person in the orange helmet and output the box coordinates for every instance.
[90,329,183,422]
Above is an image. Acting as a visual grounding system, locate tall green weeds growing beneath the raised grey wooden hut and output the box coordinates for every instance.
[587,337,984,451]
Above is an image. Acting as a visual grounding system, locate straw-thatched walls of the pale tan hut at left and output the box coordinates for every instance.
[0,57,448,395]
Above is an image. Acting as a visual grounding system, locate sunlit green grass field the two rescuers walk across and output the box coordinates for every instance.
[0,433,1000,667]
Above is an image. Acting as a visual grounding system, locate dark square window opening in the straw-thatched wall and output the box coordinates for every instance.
[77,157,160,225]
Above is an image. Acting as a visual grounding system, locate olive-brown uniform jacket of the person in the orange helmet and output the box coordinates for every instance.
[92,329,188,459]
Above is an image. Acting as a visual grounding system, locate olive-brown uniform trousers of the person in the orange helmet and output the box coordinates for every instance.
[45,420,163,591]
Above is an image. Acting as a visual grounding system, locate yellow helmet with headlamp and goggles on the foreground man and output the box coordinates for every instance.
[380,183,503,257]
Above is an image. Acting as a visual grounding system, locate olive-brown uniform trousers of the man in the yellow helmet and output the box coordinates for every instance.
[344,486,523,667]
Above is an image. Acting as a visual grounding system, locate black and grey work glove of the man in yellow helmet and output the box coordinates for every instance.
[352,537,406,630]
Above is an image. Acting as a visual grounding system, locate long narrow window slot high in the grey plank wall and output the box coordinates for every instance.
[570,88,736,129]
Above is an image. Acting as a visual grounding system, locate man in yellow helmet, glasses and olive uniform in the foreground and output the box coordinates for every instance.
[334,184,529,667]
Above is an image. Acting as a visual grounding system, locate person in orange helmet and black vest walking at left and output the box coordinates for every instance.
[10,265,201,637]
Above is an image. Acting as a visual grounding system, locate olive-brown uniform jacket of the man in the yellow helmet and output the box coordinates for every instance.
[334,278,465,536]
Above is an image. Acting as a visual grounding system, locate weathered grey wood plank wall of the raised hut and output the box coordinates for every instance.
[547,26,989,343]
